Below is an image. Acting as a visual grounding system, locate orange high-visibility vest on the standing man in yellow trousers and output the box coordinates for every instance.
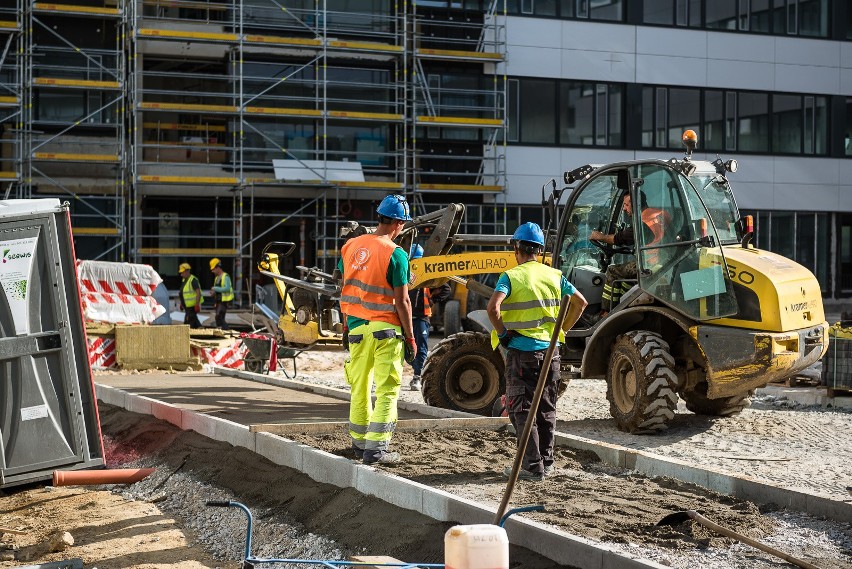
[340,233,402,326]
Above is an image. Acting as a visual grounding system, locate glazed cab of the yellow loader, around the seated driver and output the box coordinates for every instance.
[554,160,737,327]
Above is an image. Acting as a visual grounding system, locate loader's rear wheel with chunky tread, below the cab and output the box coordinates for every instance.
[606,330,678,434]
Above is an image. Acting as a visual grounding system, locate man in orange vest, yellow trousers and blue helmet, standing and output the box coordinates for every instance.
[339,195,417,464]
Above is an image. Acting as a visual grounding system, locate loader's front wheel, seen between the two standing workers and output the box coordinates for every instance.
[420,332,506,416]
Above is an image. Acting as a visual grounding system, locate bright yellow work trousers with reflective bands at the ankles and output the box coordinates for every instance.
[343,322,404,454]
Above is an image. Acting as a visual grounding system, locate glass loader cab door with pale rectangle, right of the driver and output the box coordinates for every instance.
[630,162,737,320]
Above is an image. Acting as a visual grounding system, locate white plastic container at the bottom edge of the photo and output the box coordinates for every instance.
[444,524,509,569]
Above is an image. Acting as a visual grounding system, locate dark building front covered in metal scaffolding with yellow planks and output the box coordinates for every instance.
[0,0,506,300]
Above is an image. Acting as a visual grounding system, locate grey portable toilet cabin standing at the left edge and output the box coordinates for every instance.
[0,199,104,488]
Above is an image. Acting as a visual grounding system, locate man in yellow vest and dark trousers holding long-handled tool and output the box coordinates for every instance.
[487,222,588,481]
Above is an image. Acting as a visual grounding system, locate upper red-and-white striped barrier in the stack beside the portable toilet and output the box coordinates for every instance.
[77,261,163,296]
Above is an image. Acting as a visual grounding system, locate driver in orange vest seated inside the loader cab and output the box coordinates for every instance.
[589,194,671,321]
